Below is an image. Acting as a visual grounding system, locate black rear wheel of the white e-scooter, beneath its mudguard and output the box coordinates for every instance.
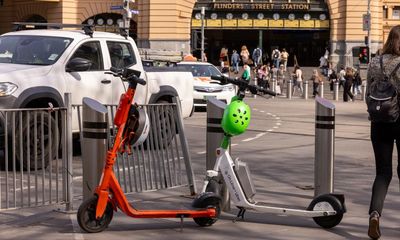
[307,194,344,228]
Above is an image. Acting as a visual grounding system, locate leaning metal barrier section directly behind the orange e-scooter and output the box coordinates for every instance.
[73,97,196,194]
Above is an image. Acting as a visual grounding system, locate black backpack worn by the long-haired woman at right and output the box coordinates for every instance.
[366,56,400,123]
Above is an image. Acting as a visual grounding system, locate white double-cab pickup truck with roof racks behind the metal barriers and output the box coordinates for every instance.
[0,23,193,167]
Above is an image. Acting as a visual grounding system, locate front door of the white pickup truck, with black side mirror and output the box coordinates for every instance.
[65,41,112,104]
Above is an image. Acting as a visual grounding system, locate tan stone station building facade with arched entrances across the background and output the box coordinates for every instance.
[0,0,400,66]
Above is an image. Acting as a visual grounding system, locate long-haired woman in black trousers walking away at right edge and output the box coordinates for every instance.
[367,25,400,239]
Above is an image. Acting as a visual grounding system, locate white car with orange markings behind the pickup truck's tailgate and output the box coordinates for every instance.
[177,61,235,107]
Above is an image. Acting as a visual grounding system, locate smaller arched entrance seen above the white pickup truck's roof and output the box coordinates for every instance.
[82,13,137,40]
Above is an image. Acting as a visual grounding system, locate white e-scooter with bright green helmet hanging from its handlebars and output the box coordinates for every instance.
[202,76,346,228]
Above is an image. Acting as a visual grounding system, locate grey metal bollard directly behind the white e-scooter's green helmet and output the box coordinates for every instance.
[206,97,230,212]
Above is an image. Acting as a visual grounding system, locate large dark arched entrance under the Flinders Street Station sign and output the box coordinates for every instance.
[191,0,330,66]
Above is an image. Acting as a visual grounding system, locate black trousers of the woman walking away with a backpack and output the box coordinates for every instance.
[369,121,400,214]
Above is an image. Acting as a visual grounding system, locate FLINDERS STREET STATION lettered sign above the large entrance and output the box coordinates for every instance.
[213,3,311,10]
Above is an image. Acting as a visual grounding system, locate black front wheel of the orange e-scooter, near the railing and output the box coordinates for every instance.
[77,196,114,233]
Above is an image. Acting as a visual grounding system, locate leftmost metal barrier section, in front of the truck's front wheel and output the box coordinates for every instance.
[0,108,67,209]
